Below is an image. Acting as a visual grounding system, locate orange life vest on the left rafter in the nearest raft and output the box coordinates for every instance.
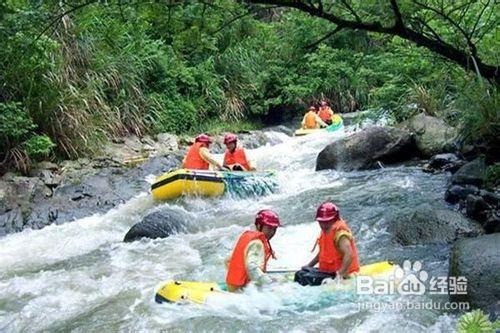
[226,230,272,288]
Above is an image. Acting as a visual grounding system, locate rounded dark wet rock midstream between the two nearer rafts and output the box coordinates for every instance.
[123,210,188,242]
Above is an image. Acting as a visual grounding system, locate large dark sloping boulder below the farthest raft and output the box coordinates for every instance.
[316,126,414,171]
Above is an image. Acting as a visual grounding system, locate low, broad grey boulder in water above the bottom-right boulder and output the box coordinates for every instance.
[389,206,483,245]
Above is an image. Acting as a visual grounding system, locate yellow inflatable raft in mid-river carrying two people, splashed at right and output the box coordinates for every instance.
[151,169,277,200]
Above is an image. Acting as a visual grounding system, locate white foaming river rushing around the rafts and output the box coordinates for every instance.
[0,126,457,332]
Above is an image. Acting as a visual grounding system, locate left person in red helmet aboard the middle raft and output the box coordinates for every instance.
[182,134,223,170]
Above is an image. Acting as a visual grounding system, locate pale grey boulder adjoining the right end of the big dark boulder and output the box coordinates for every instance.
[404,113,458,157]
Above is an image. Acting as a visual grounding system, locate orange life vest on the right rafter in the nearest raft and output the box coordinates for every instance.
[318,220,359,274]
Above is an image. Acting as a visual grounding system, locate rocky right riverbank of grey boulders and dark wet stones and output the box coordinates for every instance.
[316,114,500,315]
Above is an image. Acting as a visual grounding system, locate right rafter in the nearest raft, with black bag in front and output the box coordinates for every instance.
[295,202,359,285]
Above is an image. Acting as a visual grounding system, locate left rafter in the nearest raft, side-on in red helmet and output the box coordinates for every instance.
[226,209,281,291]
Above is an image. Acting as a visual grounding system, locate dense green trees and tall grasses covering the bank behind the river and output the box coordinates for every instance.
[0,0,500,170]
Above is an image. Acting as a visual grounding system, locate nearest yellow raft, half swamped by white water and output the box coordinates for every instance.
[155,261,399,304]
